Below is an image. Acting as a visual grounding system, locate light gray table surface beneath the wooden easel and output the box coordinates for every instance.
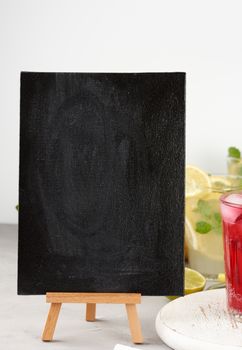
[0,224,170,350]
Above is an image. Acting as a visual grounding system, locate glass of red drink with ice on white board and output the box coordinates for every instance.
[220,192,242,317]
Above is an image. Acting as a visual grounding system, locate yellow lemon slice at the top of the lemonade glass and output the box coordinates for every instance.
[185,165,211,198]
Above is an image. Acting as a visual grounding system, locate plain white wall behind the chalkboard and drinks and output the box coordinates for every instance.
[0,0,242,223]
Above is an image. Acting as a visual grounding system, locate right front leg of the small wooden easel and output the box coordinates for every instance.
[125,304,143,344]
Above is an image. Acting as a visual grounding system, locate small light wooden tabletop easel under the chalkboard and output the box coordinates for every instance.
[42,293,143,344]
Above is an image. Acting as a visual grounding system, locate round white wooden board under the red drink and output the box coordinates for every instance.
[156,289,242,350]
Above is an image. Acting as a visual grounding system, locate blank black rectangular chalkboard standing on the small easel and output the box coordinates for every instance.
[18,72,185,295]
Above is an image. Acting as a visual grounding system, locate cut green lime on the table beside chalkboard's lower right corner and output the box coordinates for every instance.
[167,267,206,300]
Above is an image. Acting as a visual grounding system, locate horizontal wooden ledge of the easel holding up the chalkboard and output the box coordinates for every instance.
[46,293,141,304]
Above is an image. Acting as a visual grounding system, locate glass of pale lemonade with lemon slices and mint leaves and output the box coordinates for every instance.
[185,166,242,277]
